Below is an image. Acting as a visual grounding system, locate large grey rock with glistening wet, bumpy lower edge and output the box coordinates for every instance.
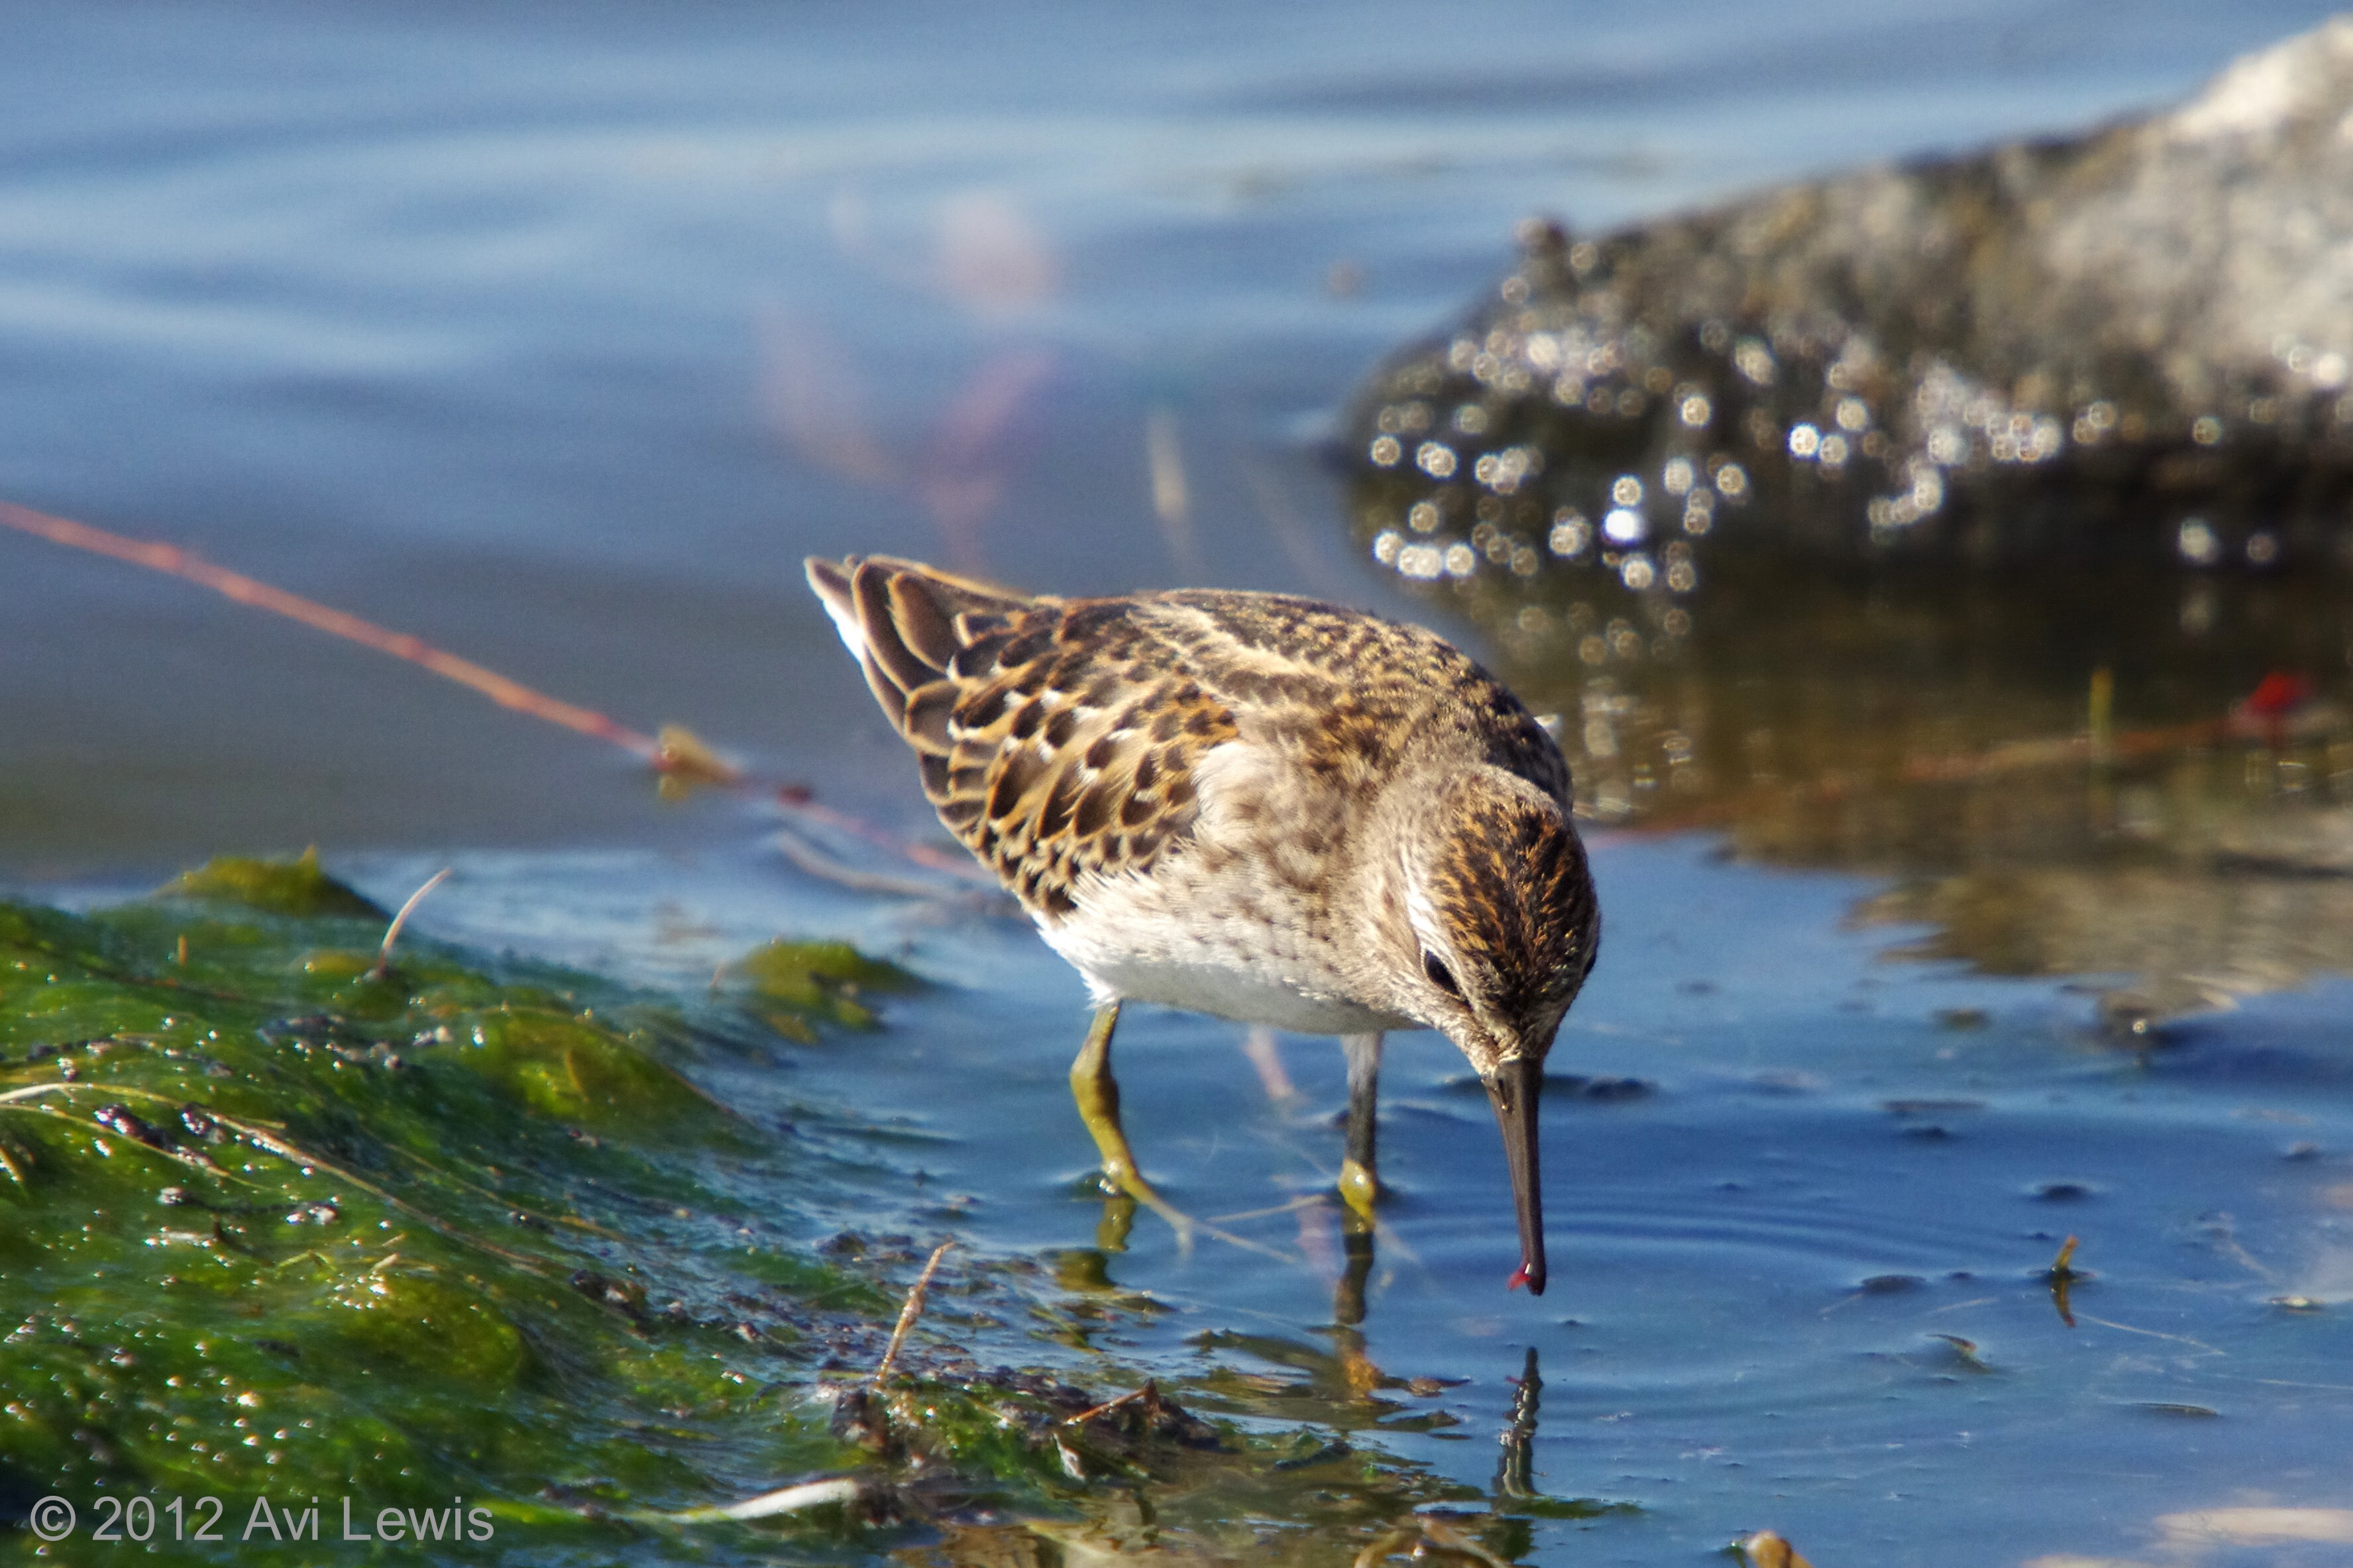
[1346,19,2353,601]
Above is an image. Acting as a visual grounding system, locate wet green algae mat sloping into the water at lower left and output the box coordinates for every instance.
[0,856,1525,1563]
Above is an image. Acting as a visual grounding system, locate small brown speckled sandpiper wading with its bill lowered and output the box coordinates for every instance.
[807,554,1600,1293]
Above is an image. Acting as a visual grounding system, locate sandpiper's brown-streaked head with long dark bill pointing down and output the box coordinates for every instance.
[1386,766,1600,1295]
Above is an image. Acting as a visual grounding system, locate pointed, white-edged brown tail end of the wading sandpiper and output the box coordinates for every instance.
[804,554,1050,755]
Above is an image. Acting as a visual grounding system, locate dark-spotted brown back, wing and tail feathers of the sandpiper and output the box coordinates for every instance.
[810,557,1570,921]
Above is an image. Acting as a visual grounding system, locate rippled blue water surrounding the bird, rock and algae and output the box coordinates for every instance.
[0,5,2353,1568]
